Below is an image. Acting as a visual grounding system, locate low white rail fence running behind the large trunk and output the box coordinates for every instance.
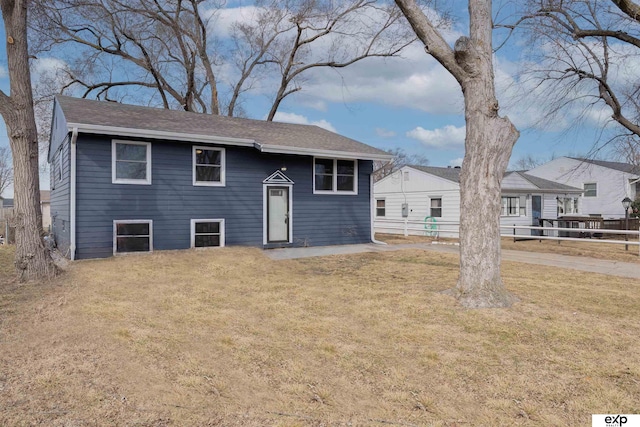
[374,219,640,255]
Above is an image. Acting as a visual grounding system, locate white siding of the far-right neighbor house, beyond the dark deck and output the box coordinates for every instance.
[527,157,636,218]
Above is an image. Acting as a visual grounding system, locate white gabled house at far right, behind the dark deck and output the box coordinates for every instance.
[527,157,640,218]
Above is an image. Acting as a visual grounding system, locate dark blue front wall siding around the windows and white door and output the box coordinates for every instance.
[75,135,372,259]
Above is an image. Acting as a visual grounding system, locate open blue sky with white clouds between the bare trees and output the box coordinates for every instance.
[0,2,624,196]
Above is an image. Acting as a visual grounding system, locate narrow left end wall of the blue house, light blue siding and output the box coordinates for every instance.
[50,136,71,256]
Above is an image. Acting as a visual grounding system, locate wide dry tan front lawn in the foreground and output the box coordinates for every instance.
[0,248,640,426]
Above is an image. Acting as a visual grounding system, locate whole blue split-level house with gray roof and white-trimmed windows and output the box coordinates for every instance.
[48,96,390,259]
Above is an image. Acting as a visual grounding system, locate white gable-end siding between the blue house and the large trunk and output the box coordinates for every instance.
[374,169,460,237]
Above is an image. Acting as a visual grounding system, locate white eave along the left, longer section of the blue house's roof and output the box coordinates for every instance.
[67,123,256,147]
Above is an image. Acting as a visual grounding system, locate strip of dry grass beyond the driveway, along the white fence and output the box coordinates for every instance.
[376,234,640,263]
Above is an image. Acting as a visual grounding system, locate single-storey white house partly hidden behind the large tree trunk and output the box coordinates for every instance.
[373,166,583,237]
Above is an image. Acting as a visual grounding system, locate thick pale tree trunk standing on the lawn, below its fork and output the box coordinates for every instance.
[455,113,518,308]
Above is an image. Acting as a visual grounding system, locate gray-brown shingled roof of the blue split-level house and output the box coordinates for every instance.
[56,95,391,158]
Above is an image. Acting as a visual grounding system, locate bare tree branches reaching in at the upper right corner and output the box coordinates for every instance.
[500,0,640,142]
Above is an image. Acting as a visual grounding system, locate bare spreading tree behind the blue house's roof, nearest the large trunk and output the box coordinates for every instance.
[260,0,415,120]
